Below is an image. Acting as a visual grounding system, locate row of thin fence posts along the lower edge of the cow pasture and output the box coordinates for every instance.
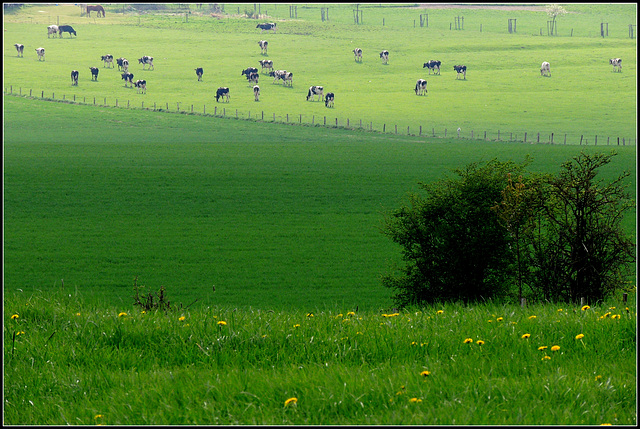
[4,85,637,146]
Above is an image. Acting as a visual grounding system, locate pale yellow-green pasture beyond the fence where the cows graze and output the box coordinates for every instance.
[3,4,637,144]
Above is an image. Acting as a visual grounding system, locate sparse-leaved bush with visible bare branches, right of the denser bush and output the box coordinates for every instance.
[527,152,635,302]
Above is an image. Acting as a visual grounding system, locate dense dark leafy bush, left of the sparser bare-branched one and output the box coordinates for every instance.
[382,160,525,306]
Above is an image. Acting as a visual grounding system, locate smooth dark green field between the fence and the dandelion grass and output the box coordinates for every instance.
[4,97,636,311]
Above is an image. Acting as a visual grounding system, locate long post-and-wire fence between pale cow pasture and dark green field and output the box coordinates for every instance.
[4,85,637,146]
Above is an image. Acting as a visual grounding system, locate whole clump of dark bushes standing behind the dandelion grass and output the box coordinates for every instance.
[382,152,636,307]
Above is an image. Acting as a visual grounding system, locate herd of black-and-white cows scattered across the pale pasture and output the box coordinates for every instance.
[14,21,622,107]
